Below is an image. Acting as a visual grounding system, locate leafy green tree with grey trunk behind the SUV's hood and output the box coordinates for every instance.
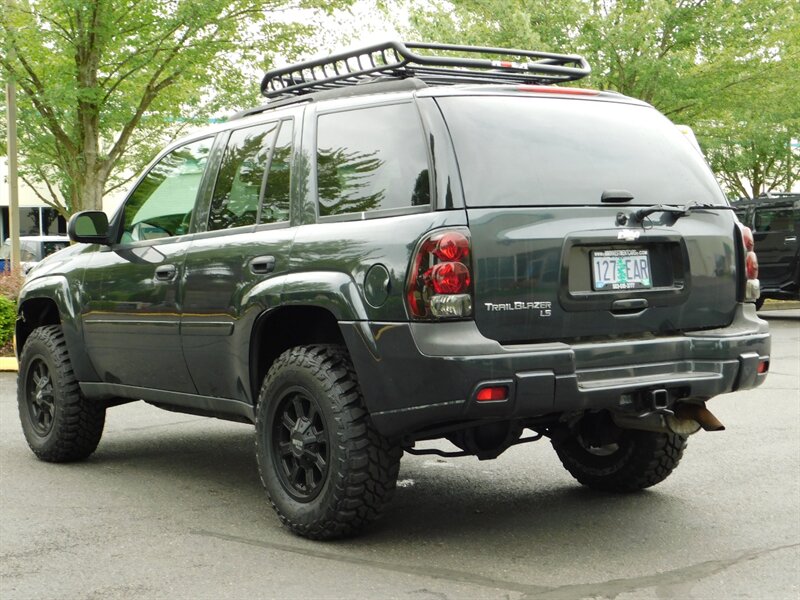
[0,0,349,216]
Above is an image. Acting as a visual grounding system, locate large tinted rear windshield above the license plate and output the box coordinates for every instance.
[438,96,725,207]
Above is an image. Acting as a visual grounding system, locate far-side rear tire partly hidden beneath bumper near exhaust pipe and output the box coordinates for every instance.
[552,429,686,492]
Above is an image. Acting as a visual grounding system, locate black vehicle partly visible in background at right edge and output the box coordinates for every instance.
[734,193,800,308]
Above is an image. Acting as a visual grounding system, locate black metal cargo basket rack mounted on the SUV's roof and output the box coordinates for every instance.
[261,41,591,99]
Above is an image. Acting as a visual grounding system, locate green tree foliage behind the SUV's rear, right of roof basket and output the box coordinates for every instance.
[396,0,800,196]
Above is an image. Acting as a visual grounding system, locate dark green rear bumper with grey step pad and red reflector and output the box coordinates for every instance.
[340,304,770,436]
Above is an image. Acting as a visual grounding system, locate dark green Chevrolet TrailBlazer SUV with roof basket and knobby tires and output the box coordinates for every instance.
[17,42,770,539]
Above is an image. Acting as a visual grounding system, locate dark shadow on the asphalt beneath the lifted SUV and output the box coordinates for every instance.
[79,425,686,562]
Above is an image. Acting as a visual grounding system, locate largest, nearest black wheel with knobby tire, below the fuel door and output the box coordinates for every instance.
[256,345,402,539]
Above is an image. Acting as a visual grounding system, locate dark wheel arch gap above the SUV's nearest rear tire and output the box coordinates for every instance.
[250,306,344,404]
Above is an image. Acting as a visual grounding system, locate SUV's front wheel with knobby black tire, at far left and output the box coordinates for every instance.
[17,325,106,462]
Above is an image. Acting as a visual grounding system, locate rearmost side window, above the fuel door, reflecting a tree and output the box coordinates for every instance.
[317,103,431,217]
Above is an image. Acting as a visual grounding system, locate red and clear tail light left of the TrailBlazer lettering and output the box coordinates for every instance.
[406,228,472,319]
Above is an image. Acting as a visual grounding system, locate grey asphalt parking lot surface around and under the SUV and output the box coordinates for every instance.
[0,310,800,600]
